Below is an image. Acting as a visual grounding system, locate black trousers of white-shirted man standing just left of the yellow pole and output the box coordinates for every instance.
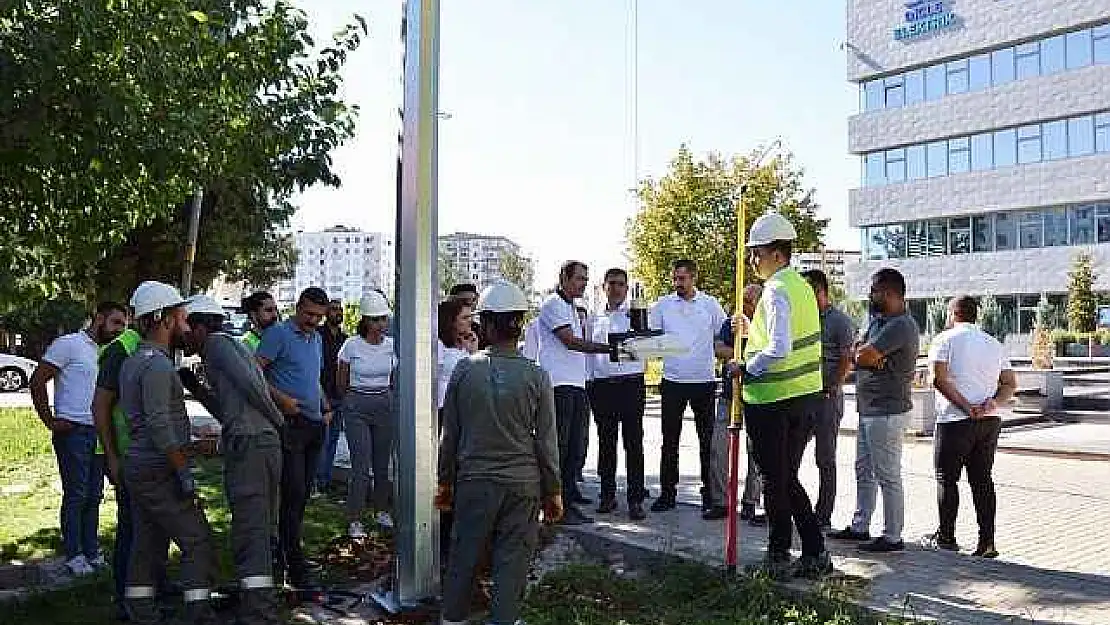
[659,380,717,506]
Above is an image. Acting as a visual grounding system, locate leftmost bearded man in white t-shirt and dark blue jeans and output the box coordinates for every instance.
[30,302,128,576]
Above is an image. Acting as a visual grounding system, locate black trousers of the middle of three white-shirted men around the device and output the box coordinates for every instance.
[587,375,647,503]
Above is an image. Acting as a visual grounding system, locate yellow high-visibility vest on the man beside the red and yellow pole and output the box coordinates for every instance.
[744,266,823,404]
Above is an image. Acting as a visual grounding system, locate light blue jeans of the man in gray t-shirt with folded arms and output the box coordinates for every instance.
[851,413,909,543]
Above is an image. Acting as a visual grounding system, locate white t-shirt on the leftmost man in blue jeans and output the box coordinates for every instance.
[42,330,98,425]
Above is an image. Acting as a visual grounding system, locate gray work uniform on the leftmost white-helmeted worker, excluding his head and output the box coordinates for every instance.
[120,341,216,624]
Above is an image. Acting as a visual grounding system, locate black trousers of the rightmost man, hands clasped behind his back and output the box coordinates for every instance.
[932,417,1002,545]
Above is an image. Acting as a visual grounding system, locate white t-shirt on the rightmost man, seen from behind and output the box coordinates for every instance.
[929,323,1010,423]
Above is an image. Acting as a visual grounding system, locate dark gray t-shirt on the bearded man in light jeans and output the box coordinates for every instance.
[856,312,920,416]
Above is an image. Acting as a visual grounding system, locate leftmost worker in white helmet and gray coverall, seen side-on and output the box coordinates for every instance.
[120,282,216,625]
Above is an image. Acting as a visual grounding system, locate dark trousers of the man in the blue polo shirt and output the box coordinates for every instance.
[278,419,325,585]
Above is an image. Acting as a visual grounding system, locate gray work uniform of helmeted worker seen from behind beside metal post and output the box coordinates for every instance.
[438,347,562,625]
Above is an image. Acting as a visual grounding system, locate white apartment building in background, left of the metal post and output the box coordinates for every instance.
[274,225,395,308]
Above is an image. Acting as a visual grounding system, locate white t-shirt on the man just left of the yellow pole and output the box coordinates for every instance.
[649,291,727,383]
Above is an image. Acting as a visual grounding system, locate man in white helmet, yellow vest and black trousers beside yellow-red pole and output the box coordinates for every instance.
[736,212,833,577]
